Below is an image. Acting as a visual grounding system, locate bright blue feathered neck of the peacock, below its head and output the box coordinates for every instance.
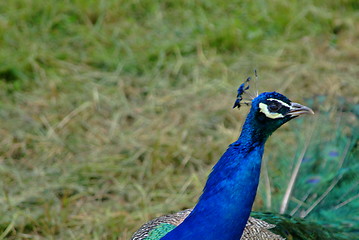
[162,115,267,240]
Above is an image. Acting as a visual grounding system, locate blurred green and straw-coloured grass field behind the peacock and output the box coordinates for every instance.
[0,0,359,240]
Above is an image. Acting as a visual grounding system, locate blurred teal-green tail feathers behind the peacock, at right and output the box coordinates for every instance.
[259,98,359,239]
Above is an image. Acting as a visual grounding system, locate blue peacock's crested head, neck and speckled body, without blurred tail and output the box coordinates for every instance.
[131,78,354,240]
